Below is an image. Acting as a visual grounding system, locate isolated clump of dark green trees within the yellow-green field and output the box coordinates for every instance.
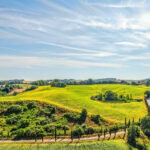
[91,91,133,102]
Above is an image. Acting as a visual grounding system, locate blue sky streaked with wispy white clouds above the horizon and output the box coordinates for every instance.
[0,0,150,80]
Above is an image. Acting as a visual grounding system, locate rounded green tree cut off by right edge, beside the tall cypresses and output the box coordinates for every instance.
[141,116,150,137]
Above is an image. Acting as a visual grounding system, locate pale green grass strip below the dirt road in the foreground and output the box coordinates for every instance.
[0,140,136,150]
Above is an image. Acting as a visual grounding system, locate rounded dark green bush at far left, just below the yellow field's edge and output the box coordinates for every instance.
[5,105,22,115]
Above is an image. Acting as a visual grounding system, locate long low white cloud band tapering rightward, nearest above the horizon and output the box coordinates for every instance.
[0,55,122,68]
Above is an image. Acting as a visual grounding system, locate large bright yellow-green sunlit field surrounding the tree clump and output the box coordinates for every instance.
[0,84,150,122]
